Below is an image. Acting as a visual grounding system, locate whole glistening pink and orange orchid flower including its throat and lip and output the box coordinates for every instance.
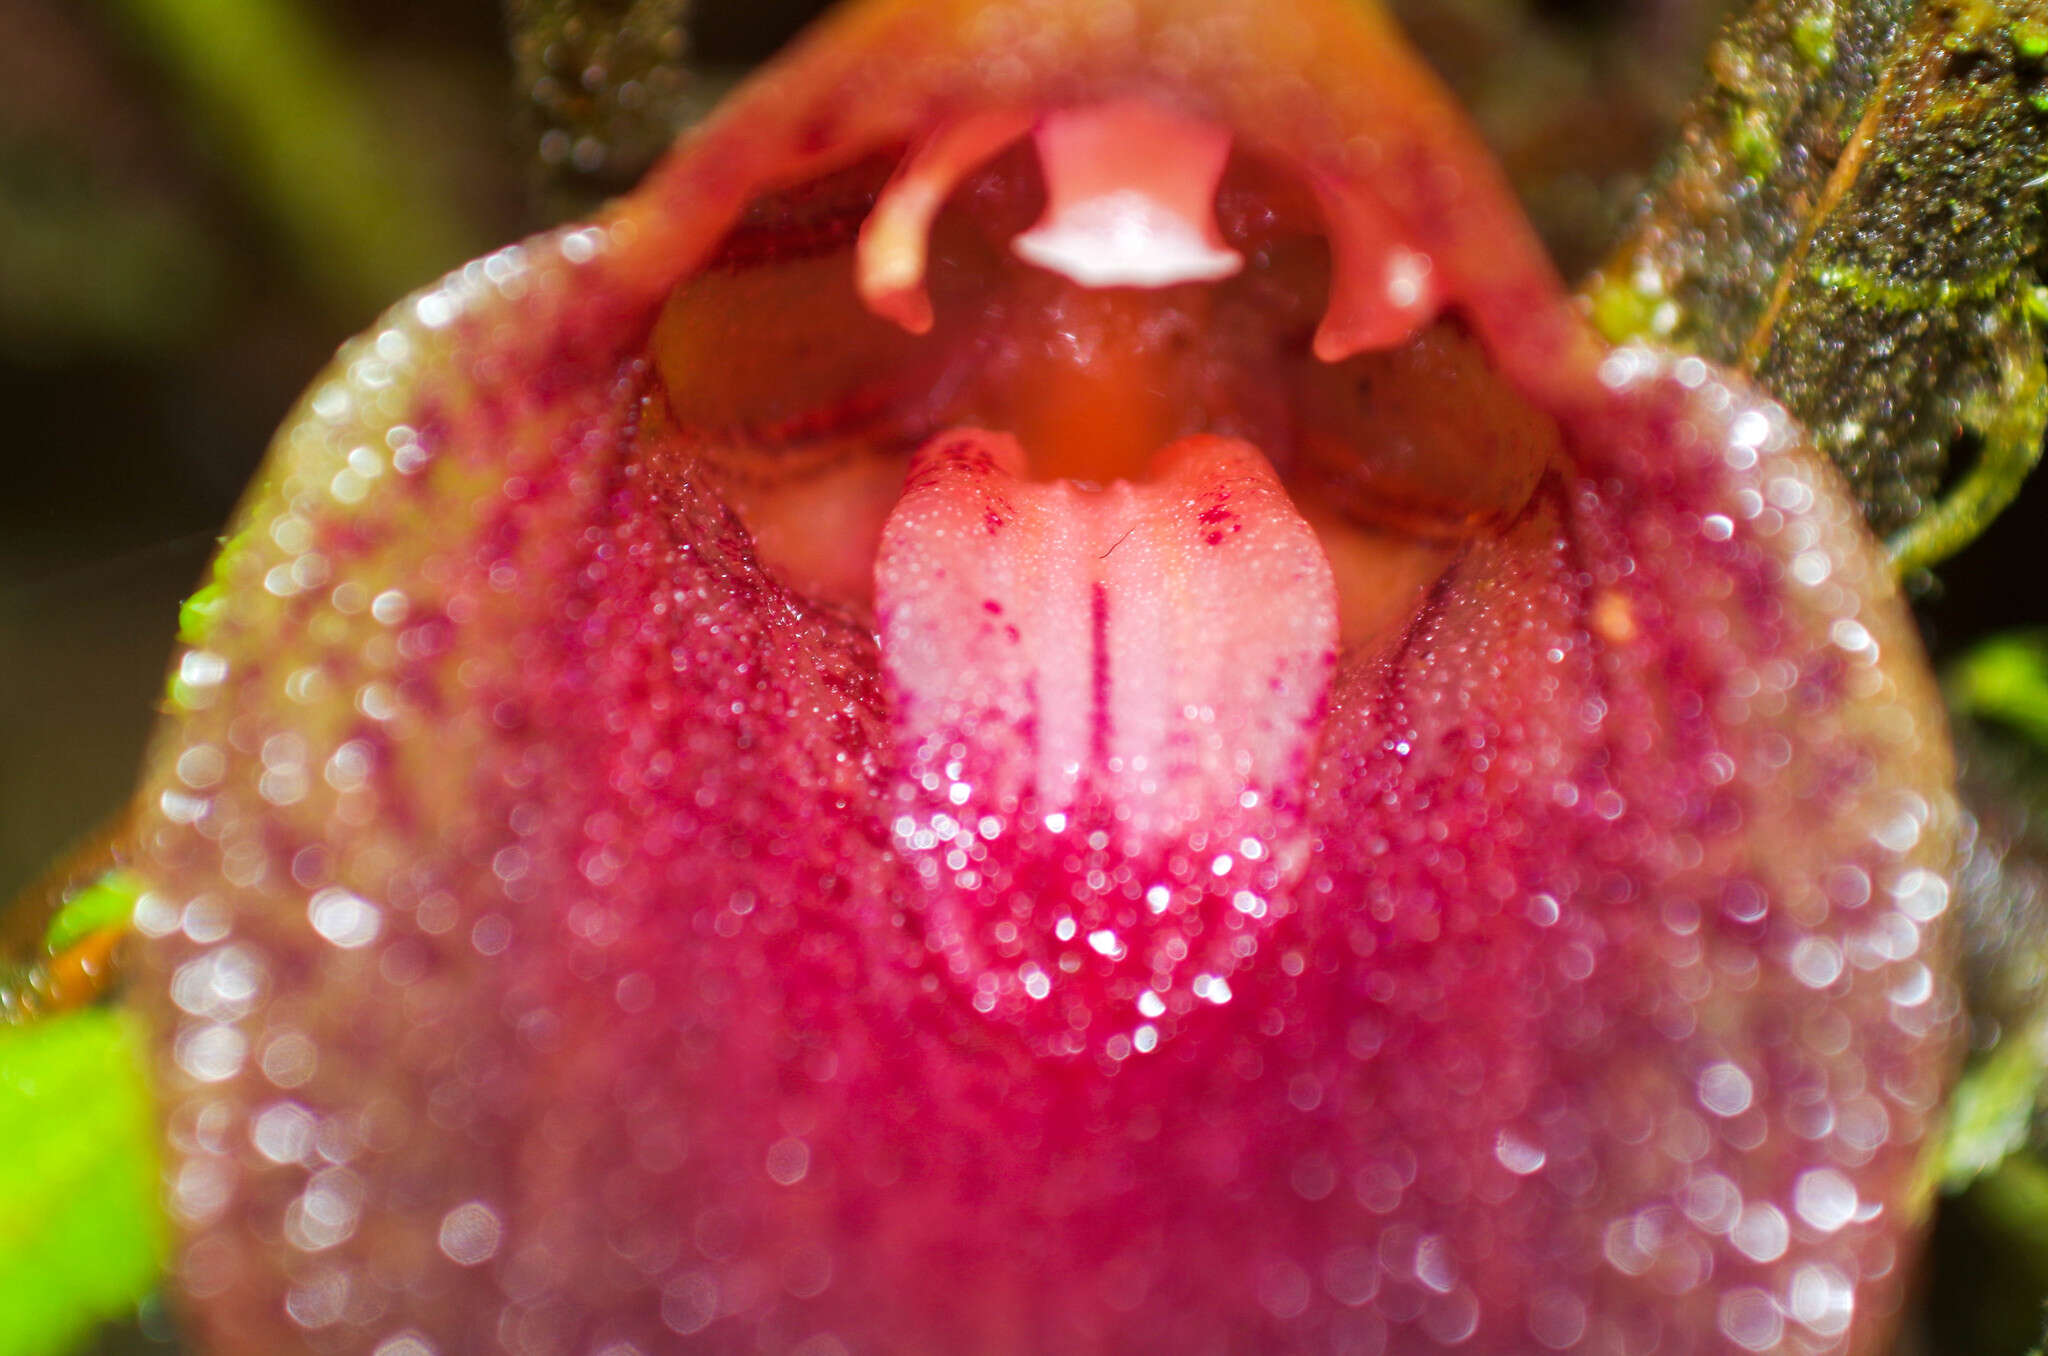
[137,0,1956,1356]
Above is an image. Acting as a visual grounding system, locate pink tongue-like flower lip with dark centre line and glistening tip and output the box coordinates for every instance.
[877,432,1337,1053]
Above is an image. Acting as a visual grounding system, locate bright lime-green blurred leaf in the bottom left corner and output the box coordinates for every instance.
[0,1008,166,1356]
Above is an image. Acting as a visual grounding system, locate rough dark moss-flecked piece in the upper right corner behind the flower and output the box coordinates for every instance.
[1589,0,2048,561]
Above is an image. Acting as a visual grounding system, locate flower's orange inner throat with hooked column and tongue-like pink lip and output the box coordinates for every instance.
[641,53,1563,1053]
